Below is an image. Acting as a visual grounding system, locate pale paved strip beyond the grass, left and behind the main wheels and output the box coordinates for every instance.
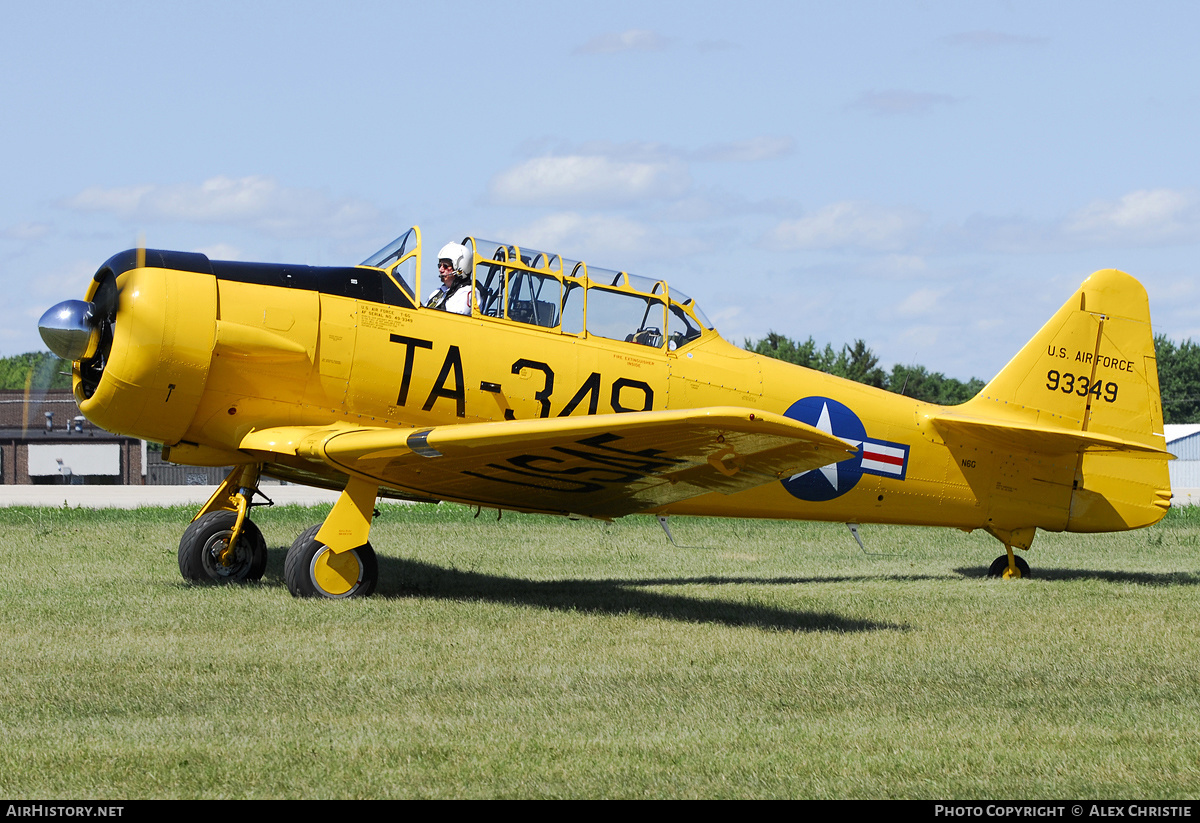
[0,485,338,509]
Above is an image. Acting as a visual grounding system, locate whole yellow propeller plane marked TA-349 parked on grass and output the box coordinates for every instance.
[40,227,1171,597]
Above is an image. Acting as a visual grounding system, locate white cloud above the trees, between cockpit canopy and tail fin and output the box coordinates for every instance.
[764,202,925,252]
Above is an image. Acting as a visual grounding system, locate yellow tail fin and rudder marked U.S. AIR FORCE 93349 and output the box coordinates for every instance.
[952,269,1171,531]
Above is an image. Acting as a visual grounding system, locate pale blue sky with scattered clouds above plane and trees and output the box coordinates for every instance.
[0,0,1200,379]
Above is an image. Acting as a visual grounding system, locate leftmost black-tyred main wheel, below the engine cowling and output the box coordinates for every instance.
[179,510,266,583]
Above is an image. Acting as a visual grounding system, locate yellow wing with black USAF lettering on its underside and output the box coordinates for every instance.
[241,407,857,517]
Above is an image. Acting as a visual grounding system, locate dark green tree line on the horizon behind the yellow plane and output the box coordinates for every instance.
[7,331,1200,423]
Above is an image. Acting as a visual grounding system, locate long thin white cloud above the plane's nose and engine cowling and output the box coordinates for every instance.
[64,175,382,236]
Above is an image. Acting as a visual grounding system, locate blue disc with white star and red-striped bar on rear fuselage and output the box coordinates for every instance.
[782,397,908,501]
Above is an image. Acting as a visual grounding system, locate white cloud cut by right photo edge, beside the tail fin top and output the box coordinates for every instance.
[1063,188,1200,242]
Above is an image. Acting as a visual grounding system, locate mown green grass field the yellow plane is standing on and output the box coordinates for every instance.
[0,506,1200,799]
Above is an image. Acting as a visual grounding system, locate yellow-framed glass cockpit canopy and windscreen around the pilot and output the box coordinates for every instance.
[361,226,713,350]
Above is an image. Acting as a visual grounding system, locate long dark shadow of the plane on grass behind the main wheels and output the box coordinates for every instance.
[264,547,907,632]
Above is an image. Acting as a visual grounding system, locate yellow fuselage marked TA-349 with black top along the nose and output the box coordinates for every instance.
[68,253,1051,537]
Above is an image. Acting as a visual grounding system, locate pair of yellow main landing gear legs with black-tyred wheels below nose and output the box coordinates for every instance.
[179,465,379,599]
